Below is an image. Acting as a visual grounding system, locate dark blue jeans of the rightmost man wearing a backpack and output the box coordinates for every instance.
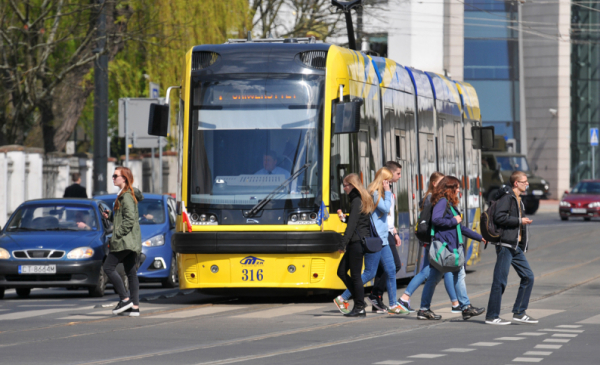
[486,246,534,319]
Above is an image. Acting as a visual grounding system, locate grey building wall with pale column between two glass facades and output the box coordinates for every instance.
[522,0,571,199]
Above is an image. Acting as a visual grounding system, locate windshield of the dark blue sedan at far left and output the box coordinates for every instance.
[6,204,98,232]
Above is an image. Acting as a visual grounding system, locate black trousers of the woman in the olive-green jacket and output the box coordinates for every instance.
[104,250,140,306]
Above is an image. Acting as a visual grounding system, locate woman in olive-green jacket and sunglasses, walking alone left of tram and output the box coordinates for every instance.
[102,166,144,317]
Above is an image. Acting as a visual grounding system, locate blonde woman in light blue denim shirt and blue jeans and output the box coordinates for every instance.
[335,167,409,314]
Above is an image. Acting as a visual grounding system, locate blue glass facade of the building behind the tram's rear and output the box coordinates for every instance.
[464,0,520,146]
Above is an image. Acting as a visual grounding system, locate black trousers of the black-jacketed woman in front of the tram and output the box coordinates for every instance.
[338,241,365,309]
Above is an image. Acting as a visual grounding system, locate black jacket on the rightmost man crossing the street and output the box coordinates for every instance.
[494,185,529,252]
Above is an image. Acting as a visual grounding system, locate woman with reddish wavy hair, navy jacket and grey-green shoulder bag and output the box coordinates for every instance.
[417,176,485,320]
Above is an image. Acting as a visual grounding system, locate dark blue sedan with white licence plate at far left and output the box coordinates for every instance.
[0,199,112,298]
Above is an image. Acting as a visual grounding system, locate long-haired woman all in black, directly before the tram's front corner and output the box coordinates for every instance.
[333,174,375,317]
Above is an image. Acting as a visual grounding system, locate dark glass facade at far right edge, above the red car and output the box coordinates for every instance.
[570,1,600,186]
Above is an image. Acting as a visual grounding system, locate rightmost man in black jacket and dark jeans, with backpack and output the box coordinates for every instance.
[485,171,538,325]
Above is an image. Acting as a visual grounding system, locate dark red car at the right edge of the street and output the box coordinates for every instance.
[558,180,600,221]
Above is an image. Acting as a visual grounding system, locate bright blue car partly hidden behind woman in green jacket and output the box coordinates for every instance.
[94,193,179,288]
